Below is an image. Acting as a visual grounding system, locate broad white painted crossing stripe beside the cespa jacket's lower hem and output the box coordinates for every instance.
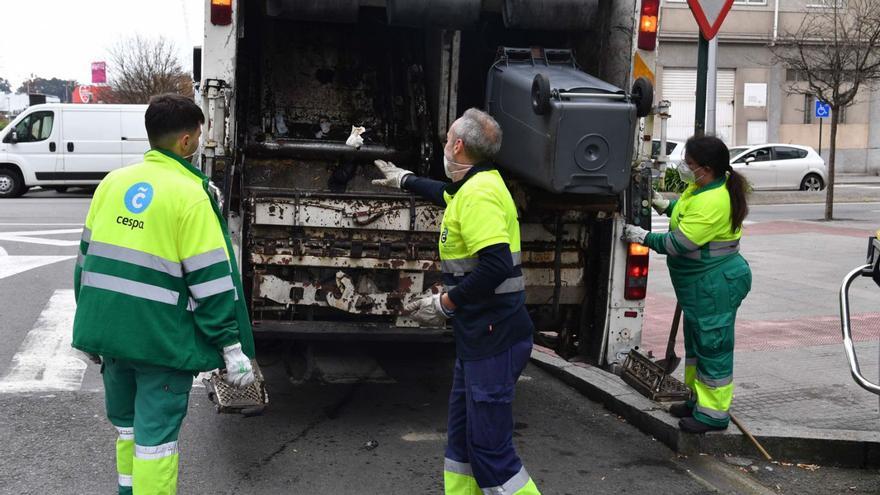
[0,289,86,393]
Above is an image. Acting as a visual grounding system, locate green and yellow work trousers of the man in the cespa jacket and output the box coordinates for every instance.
[102,358,193,495]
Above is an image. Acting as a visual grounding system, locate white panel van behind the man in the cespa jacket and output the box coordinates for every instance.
[0,103,150,198]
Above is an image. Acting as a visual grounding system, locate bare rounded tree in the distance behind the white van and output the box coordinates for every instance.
[108,35,193,103]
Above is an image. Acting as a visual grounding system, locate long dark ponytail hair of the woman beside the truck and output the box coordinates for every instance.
[684,136,749,232]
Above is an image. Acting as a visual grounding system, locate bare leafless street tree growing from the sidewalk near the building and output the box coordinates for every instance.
[771,0,880,220]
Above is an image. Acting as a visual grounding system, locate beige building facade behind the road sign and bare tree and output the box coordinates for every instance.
[654,0,880,175]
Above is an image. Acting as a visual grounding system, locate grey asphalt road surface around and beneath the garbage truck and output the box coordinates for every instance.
[0,192,880,494]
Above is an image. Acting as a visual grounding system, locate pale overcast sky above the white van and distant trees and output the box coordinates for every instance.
[0,0,205,91]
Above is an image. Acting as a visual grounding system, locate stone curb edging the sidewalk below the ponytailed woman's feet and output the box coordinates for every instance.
[532,345,880,468]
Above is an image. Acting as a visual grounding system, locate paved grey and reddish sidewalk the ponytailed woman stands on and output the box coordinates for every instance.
[539,215,880,467]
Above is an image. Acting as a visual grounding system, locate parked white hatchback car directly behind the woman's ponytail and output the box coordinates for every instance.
[730,144,827,191]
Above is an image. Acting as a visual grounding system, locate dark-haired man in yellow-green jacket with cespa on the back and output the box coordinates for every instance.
[73,95,254,495]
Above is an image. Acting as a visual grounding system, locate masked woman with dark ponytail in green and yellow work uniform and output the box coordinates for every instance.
[623,136,752,433]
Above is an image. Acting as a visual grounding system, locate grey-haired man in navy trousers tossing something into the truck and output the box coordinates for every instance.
[373,108,540,495]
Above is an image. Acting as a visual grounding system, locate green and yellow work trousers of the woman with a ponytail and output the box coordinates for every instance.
[673,256,752,427]
